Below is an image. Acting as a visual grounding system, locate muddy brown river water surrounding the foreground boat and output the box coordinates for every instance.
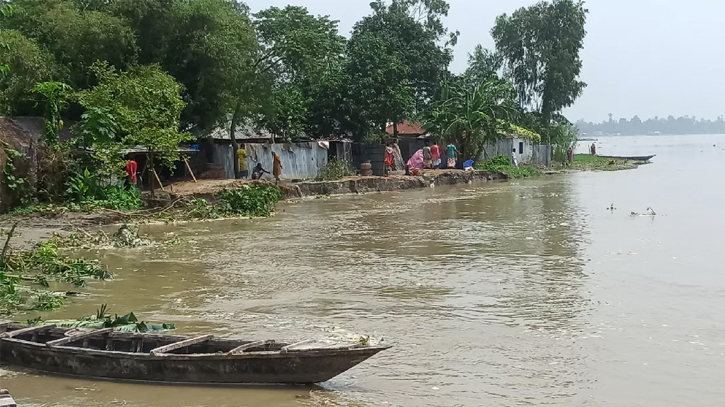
[0,136,725,407]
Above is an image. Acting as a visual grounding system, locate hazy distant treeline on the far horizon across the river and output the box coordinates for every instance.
[576,115,725,135]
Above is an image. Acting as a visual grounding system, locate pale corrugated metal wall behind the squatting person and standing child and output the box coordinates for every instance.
[247,143,327,179]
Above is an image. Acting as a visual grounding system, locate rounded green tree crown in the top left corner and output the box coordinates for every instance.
[8,0,137,89]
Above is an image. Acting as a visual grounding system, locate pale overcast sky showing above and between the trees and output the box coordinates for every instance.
[246,0,725,121]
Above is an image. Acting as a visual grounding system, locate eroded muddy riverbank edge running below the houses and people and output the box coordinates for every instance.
[0,160,646,249]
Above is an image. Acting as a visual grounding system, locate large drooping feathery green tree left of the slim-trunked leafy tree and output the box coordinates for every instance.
[111,0,258,130]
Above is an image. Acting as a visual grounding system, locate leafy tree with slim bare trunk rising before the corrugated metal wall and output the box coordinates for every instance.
[230,6,345,174]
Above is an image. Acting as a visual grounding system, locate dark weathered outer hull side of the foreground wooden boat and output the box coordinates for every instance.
[0,328,387,385]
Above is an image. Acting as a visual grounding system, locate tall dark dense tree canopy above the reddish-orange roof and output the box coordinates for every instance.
[348,0,458,139]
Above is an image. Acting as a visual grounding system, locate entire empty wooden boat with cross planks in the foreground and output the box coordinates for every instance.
[0,323,389,385]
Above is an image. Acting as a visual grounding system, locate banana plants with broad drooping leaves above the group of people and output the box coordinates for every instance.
[424,79,517,159]
